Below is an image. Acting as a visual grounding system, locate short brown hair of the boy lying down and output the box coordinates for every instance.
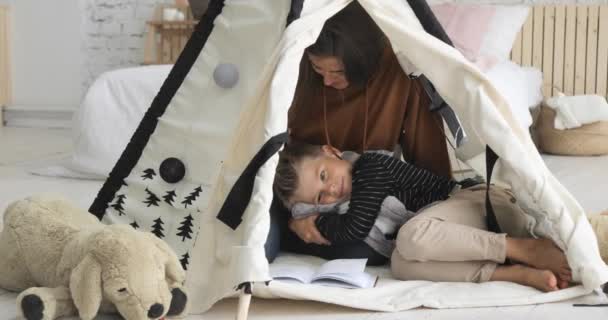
[272,142,323,209]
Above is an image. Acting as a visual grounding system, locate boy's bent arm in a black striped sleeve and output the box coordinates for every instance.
[316,154,394,244]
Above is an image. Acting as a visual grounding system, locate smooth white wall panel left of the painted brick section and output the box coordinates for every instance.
[5,0,83,107]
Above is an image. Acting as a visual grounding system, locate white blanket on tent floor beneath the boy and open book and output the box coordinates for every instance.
[253,254,605,311]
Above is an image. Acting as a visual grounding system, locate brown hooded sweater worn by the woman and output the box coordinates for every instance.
[288,46,451,177]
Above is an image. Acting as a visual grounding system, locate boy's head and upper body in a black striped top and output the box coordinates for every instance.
[274,143,457,248]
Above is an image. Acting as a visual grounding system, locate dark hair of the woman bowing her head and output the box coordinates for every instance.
[302,1,387,86]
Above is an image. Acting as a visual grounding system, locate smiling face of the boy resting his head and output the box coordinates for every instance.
[291,146,352,204]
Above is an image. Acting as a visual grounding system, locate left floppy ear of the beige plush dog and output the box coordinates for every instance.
[70,255,102,320]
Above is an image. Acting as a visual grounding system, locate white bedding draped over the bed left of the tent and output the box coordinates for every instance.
[33,65,172,179]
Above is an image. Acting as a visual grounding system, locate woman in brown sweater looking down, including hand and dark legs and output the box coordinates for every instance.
[266,2,451,264]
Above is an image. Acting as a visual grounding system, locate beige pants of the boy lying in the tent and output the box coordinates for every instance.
[391,187,530,282]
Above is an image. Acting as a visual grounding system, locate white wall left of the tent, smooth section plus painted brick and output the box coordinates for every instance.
[0,0,170,108]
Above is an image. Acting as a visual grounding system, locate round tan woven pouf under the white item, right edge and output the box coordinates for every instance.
[533,105,608,156]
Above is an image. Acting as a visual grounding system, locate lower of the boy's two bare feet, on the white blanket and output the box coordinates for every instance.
[490,264,559,292]
